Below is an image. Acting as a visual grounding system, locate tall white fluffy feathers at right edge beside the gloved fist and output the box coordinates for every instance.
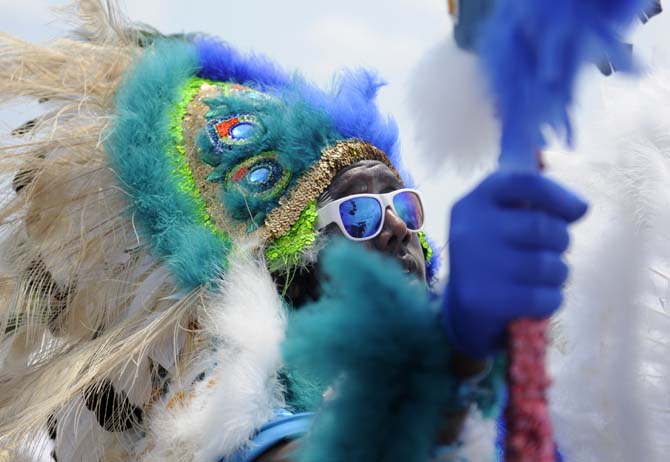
[549,66,670,462]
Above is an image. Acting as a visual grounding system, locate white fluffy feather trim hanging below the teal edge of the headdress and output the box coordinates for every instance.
[139,244,286,462]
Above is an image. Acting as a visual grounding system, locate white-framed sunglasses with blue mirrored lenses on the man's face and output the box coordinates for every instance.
[317,188,424,241]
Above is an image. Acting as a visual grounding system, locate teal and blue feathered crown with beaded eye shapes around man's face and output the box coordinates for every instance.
[106,40,440,288]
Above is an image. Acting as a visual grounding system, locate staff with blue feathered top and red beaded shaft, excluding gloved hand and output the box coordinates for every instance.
[449,0,660,462]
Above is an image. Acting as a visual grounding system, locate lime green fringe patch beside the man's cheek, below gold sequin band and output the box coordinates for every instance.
[265,201,317,271]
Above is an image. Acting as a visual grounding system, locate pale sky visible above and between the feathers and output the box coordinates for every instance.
[0,0,670,249]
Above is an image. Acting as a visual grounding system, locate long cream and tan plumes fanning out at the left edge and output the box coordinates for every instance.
[0,0,196,460]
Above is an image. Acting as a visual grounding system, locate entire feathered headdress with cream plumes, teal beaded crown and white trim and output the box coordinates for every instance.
[0,1,468,461]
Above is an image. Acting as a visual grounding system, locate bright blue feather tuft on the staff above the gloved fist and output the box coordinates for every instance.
[481,0,652,169]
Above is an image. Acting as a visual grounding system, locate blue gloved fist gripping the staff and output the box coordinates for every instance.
[441,172,587,358]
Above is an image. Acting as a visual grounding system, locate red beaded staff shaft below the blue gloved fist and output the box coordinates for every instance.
[505,319,555,462]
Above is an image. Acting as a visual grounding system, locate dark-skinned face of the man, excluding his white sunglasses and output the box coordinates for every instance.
[326,160,426,282]
